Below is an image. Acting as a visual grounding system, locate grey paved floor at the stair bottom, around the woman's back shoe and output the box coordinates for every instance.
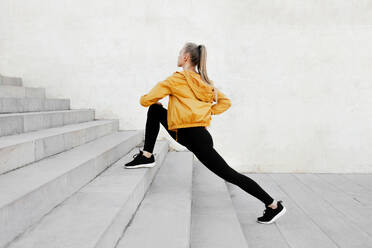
[227,173,372,248]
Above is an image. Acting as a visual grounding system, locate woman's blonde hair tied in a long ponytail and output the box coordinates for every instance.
[184,42,218,102]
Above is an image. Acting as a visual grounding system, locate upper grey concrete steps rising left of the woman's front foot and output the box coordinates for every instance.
[0,72,153,247]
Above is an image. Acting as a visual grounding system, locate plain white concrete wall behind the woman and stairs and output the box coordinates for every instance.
[0,0,372,172]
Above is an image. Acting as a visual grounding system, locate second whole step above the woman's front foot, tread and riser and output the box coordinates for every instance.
[0,120,119,174]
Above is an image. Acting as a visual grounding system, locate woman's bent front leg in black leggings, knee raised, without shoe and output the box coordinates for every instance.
[143,104,176,153]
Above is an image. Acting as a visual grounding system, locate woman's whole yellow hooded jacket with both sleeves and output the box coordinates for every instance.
[140,70,231,135]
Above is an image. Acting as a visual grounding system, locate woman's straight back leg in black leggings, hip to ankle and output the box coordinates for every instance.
[179,127,274,206]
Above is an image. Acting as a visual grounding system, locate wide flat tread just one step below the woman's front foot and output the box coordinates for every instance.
[116,151,193,248]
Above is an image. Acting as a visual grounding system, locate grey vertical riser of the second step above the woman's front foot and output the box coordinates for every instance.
[0,120,119,174]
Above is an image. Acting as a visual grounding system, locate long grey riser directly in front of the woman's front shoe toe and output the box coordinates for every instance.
[0,131,143,247]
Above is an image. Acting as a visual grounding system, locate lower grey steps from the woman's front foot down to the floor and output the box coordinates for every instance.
[1,147,254,248]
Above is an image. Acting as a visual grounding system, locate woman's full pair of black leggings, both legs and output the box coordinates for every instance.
[143,104,274,206]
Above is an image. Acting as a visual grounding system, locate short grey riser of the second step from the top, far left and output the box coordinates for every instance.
[0,85,45,98]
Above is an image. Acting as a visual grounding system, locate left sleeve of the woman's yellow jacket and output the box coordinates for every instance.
[140,75,173,107]
